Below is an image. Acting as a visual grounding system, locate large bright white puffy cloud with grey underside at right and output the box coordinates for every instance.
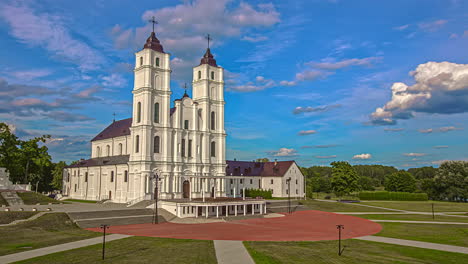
[370,62,468,125]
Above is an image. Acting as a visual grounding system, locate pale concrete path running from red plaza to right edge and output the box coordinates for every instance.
[355,236,468,254]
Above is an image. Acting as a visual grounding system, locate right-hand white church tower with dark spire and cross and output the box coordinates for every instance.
[192,35,226,176]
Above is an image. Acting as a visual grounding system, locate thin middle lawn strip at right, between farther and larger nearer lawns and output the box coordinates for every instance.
[354,214,468,223]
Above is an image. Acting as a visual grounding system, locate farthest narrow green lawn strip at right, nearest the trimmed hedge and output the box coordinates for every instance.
[361,201,468,212]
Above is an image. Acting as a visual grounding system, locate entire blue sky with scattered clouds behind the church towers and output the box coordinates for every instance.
[0,0,468,168]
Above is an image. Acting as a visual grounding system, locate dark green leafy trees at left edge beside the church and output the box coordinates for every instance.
[0,123,67,192]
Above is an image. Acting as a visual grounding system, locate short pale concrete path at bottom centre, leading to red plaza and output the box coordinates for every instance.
[213,240,255,264]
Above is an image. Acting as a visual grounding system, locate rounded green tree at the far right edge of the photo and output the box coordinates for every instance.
[434,161,468,201]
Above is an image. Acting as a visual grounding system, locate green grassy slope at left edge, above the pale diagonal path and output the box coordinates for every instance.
[0,213,99,255]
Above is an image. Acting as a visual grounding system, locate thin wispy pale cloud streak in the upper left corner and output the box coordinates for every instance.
[0,2,105,70]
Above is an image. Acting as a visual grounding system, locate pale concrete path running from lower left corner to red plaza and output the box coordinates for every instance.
[0,235,131,263]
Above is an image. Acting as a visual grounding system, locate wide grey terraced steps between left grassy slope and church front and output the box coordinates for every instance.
[68,208,166,228]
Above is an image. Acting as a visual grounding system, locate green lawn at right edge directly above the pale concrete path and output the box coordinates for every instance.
[376,223,468,247]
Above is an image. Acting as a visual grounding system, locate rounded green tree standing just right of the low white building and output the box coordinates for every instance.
[331,161,361,197]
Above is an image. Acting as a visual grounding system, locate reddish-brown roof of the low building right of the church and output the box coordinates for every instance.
[226,160,295,177]
